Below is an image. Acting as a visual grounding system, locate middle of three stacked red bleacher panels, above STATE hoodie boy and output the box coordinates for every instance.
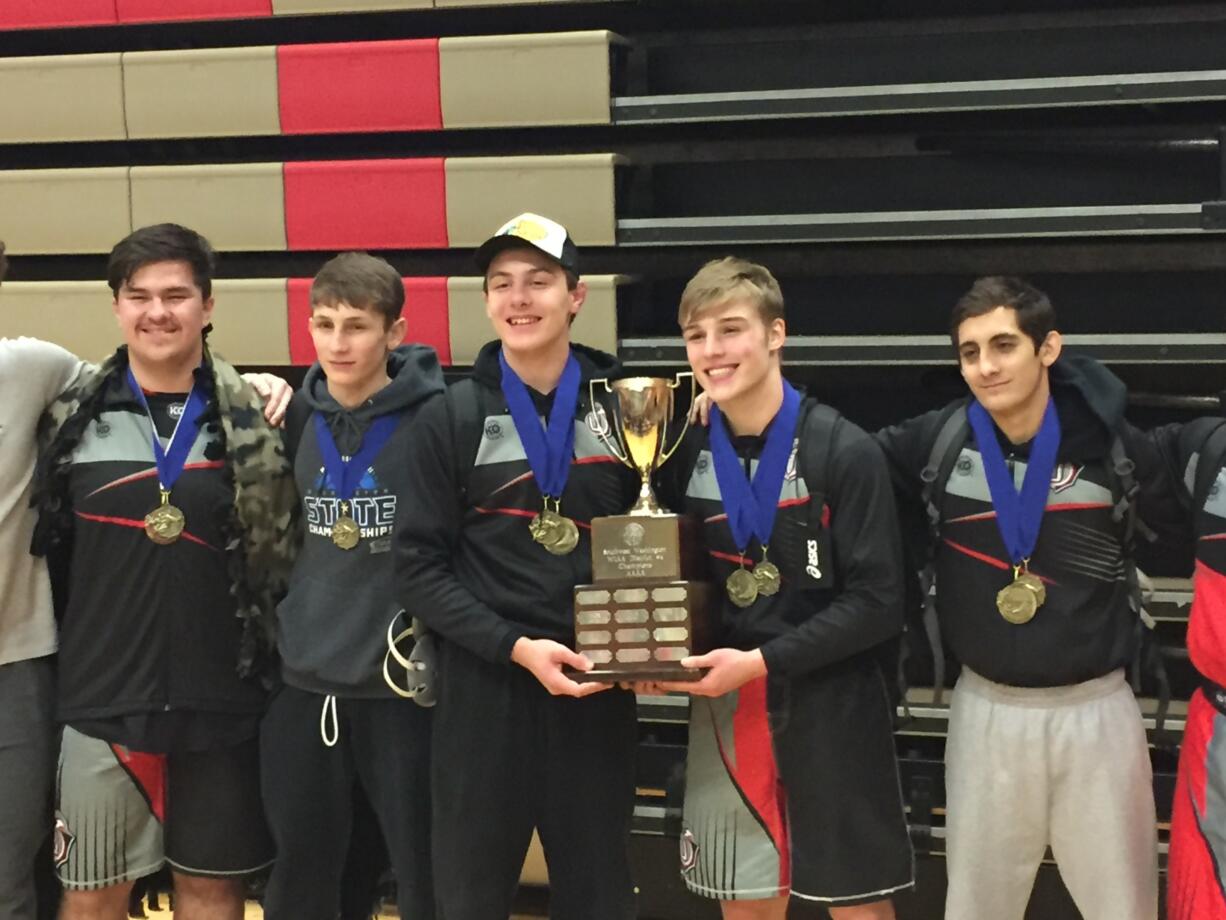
[286,157,447,250]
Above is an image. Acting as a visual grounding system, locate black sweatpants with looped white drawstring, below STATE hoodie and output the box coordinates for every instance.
[260,687,434,920]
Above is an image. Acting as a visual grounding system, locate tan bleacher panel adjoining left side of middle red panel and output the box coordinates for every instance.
[132,163,286,251]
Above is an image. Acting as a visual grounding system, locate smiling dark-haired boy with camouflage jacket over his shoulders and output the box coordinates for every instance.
[36,224,297,920]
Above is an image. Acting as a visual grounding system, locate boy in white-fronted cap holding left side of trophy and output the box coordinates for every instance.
[396,215,638,920]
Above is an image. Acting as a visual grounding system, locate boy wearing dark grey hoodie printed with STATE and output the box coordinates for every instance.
[260,253,444,920]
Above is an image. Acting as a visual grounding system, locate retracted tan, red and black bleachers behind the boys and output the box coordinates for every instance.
[0,0,1226,920]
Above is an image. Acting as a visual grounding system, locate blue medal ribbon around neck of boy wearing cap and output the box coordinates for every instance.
[498,351,581,499]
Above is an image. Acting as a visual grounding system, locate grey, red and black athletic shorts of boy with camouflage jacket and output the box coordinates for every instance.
[55,727,272,891]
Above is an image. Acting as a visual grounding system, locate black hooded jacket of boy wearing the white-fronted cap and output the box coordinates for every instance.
[396,342,638,662]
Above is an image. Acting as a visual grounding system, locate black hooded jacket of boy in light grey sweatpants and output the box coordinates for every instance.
[877,355,1182,687]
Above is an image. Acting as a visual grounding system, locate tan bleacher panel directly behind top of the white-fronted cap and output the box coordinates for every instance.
[446,153,626,248]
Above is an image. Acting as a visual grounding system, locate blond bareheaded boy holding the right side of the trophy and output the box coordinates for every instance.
[640,258,915,920]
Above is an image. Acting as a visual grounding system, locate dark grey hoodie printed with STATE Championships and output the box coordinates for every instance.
[277,345,444,697]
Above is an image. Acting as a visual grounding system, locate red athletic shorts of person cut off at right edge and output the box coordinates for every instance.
[1166,689,1226,920]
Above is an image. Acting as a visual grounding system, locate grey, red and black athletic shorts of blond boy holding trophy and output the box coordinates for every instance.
[680,661,915,907]
